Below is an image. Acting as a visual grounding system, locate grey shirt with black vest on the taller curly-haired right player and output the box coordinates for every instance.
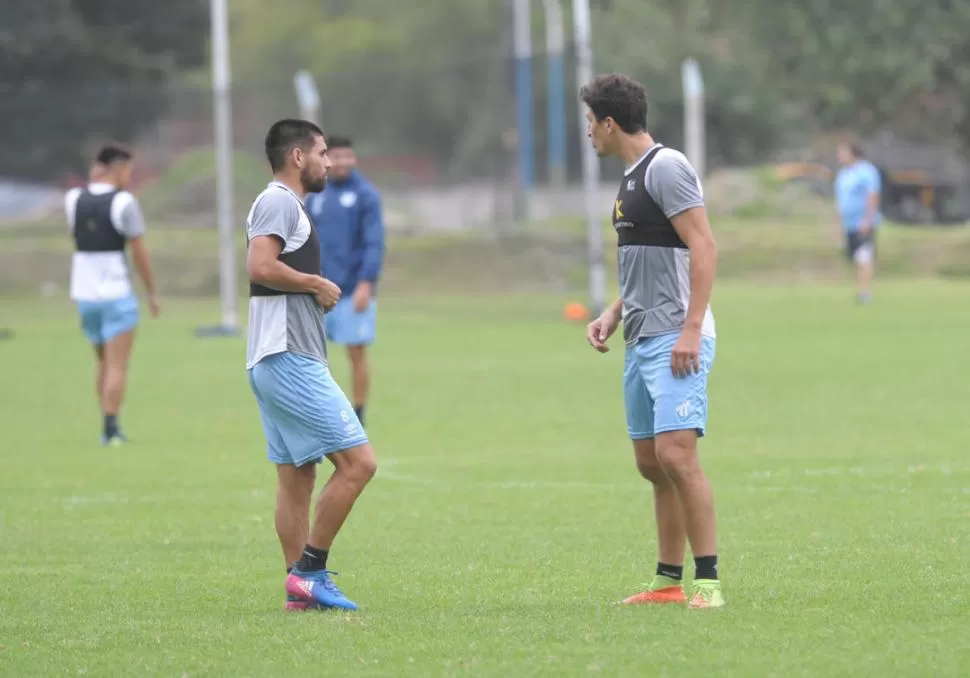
[613,144,715,345]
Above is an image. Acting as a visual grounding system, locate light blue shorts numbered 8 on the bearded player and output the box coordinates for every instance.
[249,351,367,466]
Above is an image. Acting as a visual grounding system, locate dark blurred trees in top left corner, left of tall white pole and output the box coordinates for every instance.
[0,0,209,179]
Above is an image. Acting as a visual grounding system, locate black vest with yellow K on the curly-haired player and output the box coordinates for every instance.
[613,144,687,249]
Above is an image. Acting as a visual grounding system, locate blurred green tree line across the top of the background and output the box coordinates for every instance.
[0,0,970,178]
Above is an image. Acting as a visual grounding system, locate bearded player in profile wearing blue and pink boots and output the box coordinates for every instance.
[246,119,377,610]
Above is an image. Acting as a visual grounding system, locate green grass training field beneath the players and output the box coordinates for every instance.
[0,282,970,678]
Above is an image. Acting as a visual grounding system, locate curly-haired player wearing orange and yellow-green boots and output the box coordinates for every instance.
[580,74,724,608]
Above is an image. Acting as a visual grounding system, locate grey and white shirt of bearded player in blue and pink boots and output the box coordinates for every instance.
[246,181,327,369]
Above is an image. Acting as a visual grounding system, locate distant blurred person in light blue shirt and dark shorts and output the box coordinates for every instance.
[835,141,882,304]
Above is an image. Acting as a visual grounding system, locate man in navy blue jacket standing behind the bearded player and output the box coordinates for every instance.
[307,136,384,424]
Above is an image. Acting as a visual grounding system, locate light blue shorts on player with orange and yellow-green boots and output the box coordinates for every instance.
[623,334,715,440]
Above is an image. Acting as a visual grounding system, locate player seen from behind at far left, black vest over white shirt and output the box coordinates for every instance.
[64,144,160,446]
